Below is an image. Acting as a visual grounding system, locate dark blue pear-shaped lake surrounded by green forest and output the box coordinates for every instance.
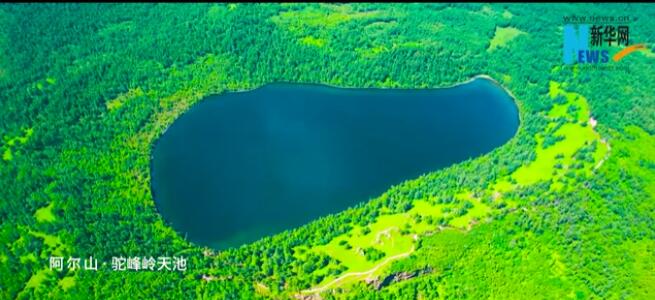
[151,79,519,249]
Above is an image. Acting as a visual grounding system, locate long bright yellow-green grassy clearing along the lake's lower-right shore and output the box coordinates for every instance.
[296,80,608,292]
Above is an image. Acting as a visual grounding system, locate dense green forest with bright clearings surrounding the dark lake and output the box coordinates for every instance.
[0,3,655,299]
